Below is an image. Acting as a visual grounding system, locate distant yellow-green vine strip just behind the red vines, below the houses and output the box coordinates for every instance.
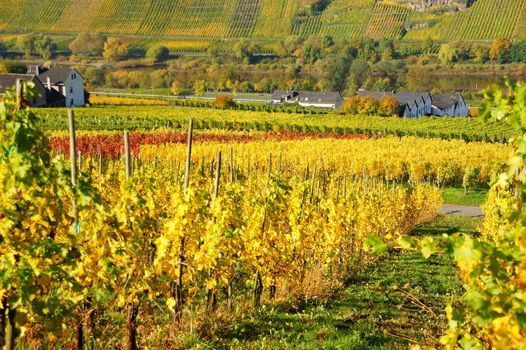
[36,106,513,143]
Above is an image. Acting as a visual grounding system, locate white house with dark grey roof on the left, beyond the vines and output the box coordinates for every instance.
[28,66,86,107]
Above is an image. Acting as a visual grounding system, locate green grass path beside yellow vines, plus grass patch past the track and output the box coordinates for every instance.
[202,216,480,349]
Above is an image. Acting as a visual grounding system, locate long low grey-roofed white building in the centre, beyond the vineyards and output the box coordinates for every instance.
[270,90,343,109]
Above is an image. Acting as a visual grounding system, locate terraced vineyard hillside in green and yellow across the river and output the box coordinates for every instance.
[0,0,526,41]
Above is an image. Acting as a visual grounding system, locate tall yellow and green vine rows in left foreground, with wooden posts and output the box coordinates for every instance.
[0,84,441,349]
